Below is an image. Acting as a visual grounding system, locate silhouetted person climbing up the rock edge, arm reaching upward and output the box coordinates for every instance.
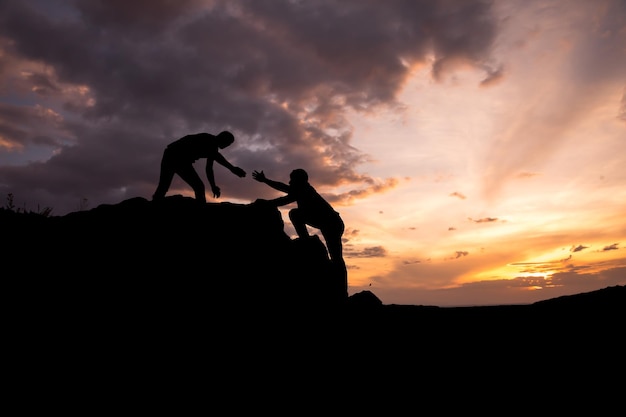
[252,169,348,297]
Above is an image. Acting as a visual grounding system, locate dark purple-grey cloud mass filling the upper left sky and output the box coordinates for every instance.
[0,0,499,213]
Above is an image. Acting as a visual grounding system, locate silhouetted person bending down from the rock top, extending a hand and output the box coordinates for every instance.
[152,131,246,203]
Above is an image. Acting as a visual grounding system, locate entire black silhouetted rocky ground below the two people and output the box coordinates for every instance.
[0,197,626,404]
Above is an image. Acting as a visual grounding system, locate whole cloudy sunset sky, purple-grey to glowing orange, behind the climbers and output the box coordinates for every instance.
[0,0,626,306]
